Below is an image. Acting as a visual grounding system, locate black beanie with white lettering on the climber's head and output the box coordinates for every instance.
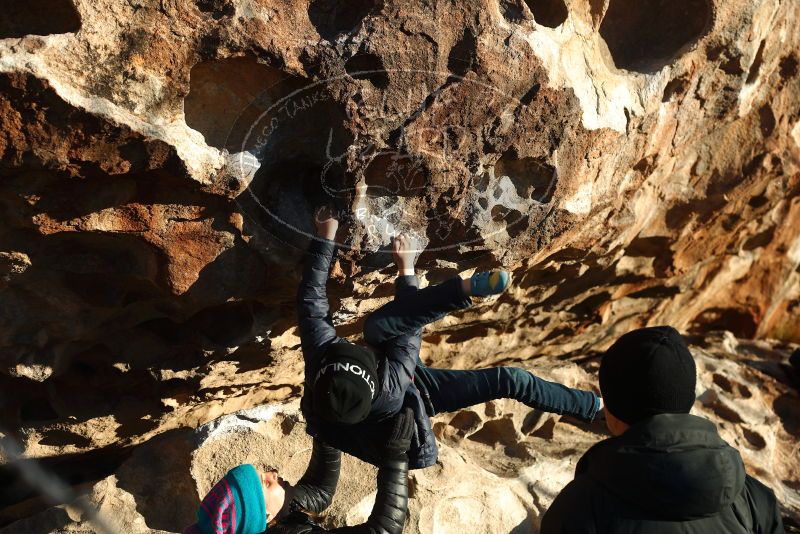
[313,342,378,424]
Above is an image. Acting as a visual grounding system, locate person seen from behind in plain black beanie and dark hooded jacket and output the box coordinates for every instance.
[541,326,783,534]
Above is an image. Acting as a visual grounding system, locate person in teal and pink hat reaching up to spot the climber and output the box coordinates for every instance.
[184,409,414,534]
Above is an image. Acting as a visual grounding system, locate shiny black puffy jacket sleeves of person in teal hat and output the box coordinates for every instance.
[267,439,408,534]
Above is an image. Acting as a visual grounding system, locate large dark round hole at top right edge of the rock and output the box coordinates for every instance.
[600,0,713,72]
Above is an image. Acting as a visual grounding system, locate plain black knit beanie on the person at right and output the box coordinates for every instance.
[600,326,697,424]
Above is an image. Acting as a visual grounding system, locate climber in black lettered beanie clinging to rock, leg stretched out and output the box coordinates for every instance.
[297,208,602,469]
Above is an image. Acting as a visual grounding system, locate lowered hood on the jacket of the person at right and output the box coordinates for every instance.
[576,414,745,521]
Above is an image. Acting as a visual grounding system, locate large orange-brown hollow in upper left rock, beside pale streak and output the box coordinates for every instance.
[188,57,308,153]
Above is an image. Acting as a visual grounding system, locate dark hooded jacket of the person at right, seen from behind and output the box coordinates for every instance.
[541,414,783,534]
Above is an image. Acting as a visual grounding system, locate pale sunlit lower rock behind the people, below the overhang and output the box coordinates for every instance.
[7,338,800,534]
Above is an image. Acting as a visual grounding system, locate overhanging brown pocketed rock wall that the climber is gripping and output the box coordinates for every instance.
[0,0,800,521]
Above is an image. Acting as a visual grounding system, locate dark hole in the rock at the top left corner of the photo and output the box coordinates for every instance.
[0,0,81,39]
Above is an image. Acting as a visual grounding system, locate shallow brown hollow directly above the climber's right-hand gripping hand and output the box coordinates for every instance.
[364,153,428,197]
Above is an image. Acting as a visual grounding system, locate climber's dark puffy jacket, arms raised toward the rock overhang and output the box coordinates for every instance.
[297,239,439,469]
